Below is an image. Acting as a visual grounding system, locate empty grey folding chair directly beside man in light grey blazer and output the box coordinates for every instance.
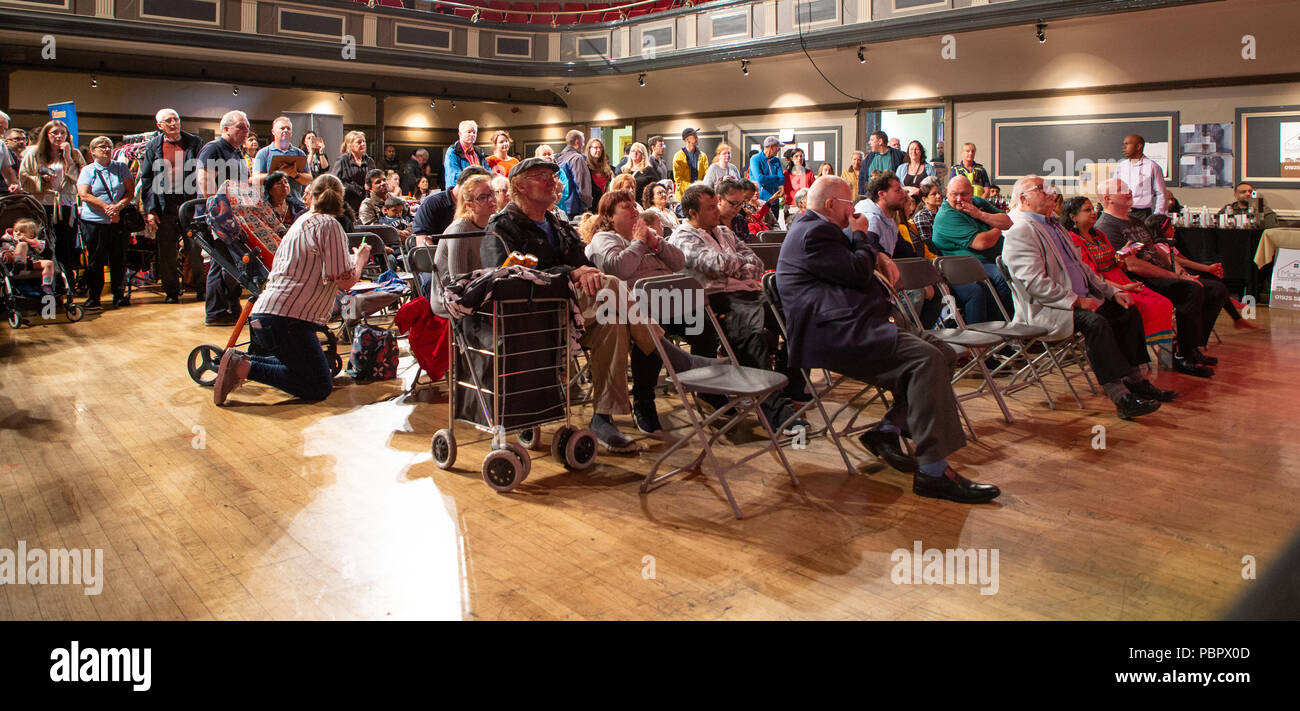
[935,255,1066,409]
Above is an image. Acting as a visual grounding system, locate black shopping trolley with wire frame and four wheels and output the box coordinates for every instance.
[432,233,597,493]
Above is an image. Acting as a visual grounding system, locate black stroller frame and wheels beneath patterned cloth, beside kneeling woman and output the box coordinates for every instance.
[178,192,343,386]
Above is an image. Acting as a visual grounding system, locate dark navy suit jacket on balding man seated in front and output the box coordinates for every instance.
[776,211,898,373]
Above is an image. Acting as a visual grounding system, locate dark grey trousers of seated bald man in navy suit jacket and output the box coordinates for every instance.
[844,329,966,464]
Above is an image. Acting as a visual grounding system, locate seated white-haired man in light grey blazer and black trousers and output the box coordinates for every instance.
[1002,175,1178,420]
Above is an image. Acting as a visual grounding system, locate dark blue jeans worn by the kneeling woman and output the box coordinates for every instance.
[248,313,334,402]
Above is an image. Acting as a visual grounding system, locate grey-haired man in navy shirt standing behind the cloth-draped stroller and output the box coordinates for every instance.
[198,110,251,326]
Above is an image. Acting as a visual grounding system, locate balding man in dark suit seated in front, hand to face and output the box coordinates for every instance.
[776,175,1001,503]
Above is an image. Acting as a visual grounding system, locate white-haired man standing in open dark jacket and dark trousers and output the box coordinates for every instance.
[140,109,207,304]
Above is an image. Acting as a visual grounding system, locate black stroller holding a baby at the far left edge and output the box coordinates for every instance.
[0,192,86,329]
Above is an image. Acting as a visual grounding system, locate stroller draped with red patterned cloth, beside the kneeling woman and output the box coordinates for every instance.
[178,182,343,386]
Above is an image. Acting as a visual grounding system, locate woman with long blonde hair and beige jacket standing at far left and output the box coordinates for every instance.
[18,121,86,281]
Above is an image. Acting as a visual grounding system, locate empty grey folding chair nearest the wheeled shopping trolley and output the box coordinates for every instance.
[638,274,800,519]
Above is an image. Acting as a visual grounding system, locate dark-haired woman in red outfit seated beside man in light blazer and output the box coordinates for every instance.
[1061,195,1174,346]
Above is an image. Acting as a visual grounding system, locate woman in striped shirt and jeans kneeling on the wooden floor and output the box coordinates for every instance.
[212,174,371,406]
